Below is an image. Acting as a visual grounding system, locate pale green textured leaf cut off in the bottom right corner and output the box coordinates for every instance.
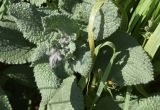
[132,96,160,110]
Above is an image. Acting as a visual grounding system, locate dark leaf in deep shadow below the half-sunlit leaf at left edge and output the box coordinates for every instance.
[3,65,36,87]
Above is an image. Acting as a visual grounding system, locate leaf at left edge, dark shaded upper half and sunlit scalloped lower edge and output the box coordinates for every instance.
[0,23,34,64]
